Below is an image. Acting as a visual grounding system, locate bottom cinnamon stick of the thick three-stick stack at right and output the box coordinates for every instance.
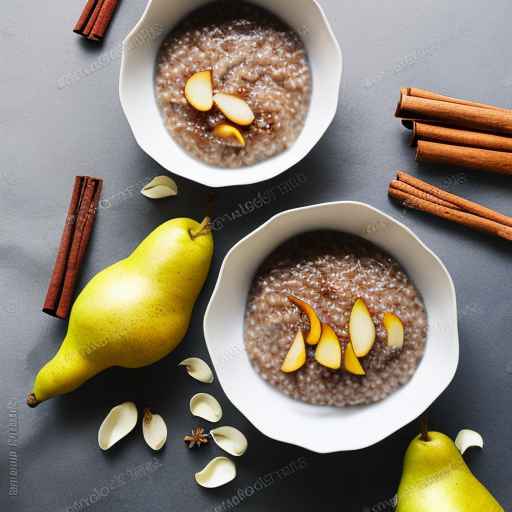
[416,140,512,175]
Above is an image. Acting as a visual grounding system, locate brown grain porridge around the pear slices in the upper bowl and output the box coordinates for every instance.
[155,1,311,168]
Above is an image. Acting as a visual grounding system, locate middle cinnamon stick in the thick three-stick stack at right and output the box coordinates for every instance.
[411,121,512,152]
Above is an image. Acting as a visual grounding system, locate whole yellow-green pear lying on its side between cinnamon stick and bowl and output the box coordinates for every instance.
[27,218,213,407]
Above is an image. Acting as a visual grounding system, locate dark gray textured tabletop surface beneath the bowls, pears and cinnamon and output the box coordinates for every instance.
[0,0,512,512]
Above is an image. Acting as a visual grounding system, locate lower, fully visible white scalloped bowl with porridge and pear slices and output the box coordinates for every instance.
[204,201,458,453]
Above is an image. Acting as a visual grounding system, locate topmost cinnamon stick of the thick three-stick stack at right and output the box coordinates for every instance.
[395,92,512,135]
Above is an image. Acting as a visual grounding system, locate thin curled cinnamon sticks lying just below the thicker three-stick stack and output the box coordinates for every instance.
[388,171,512,240]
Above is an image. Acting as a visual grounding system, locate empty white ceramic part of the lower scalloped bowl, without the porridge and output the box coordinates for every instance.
[204,201,459,453]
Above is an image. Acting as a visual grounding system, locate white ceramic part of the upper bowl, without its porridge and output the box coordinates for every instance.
[119,0,342,187]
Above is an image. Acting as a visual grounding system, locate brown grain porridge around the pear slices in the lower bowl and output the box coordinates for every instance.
[244,231,427,407]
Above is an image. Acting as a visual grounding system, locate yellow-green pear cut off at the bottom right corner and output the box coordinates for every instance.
[396,432,504,512]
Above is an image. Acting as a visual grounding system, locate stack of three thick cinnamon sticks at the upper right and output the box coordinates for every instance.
[395,87,512,175]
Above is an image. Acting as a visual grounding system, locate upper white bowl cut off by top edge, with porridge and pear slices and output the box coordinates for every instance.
[119,0,342,187]
